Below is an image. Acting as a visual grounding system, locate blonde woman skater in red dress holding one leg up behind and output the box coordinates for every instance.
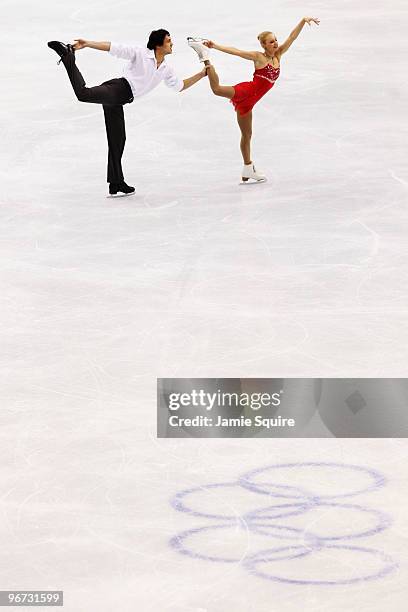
[187,17,320,183]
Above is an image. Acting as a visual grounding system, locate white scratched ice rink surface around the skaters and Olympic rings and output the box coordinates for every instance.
[0,0,408,612]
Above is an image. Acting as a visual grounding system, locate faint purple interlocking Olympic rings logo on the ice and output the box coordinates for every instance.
[170,462,398,585]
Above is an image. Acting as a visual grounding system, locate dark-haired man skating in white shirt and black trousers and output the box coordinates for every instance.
[48,29,206,196]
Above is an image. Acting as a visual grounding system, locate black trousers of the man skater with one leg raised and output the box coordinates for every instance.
[62,53,133,183]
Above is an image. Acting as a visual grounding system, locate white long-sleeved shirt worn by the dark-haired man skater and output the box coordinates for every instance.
[109,42,184,98]
